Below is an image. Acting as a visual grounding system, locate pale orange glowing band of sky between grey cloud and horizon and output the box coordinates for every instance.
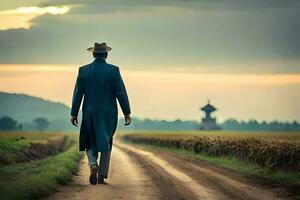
[0,64,300,120]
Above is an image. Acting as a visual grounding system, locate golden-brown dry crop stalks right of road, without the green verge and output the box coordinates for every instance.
[124,132,300,171]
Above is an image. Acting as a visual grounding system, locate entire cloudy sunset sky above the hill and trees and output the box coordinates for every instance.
[0,0,300,121]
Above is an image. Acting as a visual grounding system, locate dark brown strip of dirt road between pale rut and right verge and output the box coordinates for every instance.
[155,153,289,200]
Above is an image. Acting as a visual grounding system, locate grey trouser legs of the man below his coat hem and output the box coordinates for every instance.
[85,149,111,178]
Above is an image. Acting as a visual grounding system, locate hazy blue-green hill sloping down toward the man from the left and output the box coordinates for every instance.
[0,92,70,123]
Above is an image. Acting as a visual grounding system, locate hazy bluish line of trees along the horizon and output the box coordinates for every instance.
[0,116,300,131]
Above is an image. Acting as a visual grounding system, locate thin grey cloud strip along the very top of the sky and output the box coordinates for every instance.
[41,0,300,14]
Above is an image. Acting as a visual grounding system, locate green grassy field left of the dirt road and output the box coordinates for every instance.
[0,132,81,200]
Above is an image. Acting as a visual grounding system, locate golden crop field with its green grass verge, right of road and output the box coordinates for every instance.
[123,131,300,186]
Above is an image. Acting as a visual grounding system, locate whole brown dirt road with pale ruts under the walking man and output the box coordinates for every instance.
[48,141,289,200]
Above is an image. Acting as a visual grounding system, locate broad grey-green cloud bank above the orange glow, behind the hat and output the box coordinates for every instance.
[0,0,300,72]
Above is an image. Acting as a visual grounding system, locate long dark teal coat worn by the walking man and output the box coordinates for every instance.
[71,58,130,152]
